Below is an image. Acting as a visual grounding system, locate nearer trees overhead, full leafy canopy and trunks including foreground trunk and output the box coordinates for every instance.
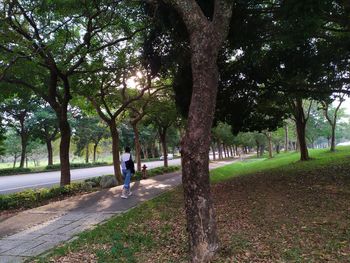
[0,0,350,262]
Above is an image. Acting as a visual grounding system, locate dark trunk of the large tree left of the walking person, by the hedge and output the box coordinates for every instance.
[59,116,71,186]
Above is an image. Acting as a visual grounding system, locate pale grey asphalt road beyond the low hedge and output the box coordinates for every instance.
[0,159,181,194]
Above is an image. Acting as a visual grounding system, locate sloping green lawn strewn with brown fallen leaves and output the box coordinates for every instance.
[34,147,350,262]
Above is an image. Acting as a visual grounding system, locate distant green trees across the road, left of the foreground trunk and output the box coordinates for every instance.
[0,94,179,170]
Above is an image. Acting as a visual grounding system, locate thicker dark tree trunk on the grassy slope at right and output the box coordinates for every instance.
[294,99,309,161]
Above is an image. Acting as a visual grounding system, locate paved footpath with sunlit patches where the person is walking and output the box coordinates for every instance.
[0,160,245,263]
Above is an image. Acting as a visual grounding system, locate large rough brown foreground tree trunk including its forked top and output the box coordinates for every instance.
[166,0,233,263]
